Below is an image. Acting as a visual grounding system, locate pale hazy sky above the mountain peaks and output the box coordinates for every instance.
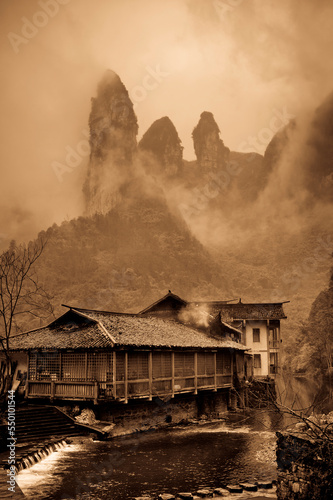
[0,0,333,245]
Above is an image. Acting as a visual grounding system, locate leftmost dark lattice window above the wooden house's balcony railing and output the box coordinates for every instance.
[29,352,60,380]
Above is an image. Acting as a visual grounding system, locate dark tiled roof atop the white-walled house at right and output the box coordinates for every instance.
[220,302,287,322]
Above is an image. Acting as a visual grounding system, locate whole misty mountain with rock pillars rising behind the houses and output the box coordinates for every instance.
[17,72,333,372]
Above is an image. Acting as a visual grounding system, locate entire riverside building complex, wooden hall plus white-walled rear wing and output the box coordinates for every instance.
[3,291,286,403]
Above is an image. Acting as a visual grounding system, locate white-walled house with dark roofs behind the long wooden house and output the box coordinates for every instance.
[141,291,288,378]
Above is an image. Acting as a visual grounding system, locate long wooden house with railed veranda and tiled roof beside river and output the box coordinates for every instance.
[7,307,246,403]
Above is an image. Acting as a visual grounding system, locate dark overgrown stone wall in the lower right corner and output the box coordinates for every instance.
[276,432,333,500]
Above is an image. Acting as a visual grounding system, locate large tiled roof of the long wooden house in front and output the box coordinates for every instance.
[11,309,246,350]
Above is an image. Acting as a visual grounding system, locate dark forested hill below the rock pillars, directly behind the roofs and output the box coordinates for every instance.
[39,189,228,318]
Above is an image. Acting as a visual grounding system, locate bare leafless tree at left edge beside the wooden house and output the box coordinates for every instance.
[0,239,52,400]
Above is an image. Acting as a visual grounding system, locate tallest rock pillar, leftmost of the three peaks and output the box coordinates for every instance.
[83,70,138,215]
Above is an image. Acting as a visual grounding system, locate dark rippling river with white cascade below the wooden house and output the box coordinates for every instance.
[18,411,281,500]
